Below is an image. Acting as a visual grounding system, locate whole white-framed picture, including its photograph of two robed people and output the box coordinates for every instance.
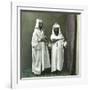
[11,2,87,88]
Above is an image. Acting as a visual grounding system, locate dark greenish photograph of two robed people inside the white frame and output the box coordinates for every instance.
[20,10,80,78]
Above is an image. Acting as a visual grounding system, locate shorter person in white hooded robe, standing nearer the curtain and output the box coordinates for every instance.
[51,23,67,72]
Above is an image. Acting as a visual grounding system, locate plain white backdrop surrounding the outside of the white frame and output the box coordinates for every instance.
[0,0,90,90]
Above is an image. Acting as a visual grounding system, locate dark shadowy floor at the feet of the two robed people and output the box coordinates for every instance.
[22,68,70,78]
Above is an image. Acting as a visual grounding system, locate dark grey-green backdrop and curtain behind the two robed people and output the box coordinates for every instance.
[20,10,77,77]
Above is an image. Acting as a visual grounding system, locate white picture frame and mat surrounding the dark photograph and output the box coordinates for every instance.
[11,2,87,88]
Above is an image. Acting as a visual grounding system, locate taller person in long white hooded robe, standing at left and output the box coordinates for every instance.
[31,19,50,75]
